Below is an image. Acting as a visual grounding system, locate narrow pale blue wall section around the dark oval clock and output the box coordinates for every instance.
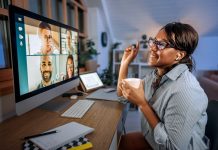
[87,7,112,72]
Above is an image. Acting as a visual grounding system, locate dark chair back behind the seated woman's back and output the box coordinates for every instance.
[205,100,218,150]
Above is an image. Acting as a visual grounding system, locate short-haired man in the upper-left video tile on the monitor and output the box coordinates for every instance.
[38,22,60,55]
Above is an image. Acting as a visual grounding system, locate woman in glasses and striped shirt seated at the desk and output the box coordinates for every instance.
[117,22,208,150]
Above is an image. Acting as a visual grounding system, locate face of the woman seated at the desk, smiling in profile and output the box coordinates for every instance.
[148,29,178,69]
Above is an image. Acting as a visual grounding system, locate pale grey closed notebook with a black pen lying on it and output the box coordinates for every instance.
[30,122,94,150]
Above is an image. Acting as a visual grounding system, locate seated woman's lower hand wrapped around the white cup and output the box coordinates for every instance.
[119,80,147,106]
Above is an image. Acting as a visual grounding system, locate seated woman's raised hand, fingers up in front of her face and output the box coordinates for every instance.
[121,42,139,65]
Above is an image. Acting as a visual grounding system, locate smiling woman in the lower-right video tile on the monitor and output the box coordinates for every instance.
[66,55,74,79]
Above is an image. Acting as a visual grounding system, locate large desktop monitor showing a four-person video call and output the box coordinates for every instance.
[9,6,79,115]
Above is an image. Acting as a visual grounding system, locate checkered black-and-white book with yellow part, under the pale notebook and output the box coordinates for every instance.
[23,137,93,150]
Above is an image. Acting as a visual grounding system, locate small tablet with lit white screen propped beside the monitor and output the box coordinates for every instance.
[79,72,104,92]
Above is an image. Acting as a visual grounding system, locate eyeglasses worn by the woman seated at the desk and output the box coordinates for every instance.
[148,37,175,50]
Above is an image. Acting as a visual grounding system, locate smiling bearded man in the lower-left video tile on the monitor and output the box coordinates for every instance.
[37,55,53,89]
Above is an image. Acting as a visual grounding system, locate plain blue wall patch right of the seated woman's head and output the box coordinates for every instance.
[193,36,218,70]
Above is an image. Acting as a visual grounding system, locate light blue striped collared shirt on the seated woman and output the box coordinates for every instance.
[141,64,208,150]
